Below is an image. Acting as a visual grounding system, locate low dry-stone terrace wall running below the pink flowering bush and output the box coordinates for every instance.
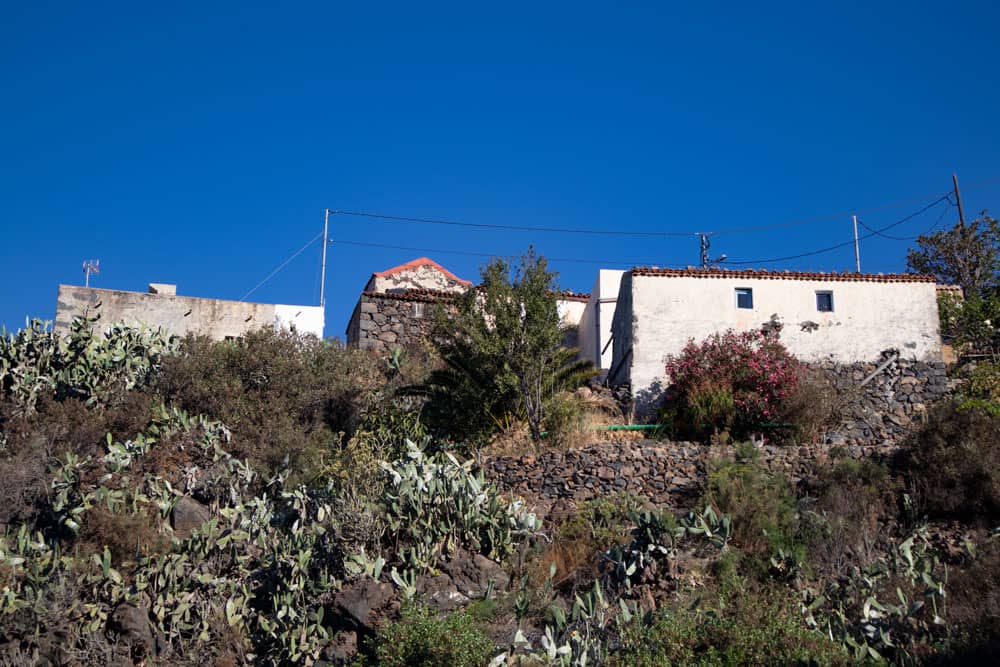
[483,440,898,509]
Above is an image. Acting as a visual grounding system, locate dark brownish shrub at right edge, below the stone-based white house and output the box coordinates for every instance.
[905,402,1000,522]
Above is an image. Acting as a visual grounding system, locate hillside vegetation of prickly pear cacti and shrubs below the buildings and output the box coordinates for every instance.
[0,253,1000,666]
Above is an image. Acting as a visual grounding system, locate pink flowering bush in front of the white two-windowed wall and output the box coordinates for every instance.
[664,329,803,439]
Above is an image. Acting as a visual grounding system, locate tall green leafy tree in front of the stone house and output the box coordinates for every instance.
[413,248,593,438]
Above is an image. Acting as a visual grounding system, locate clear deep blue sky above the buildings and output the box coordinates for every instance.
[0,2,1000,337]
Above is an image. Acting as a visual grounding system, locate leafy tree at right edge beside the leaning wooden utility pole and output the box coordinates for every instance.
[906,211,1000,299]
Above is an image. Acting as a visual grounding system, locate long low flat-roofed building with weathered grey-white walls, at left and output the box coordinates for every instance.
[55,283,323,340]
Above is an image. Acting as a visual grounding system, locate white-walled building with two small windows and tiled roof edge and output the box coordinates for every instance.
[608,268,941,416]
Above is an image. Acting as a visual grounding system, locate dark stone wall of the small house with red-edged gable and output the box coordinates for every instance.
[347,290,450,352]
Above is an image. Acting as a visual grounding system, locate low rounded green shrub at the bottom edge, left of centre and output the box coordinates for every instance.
[368,604,497,667]
